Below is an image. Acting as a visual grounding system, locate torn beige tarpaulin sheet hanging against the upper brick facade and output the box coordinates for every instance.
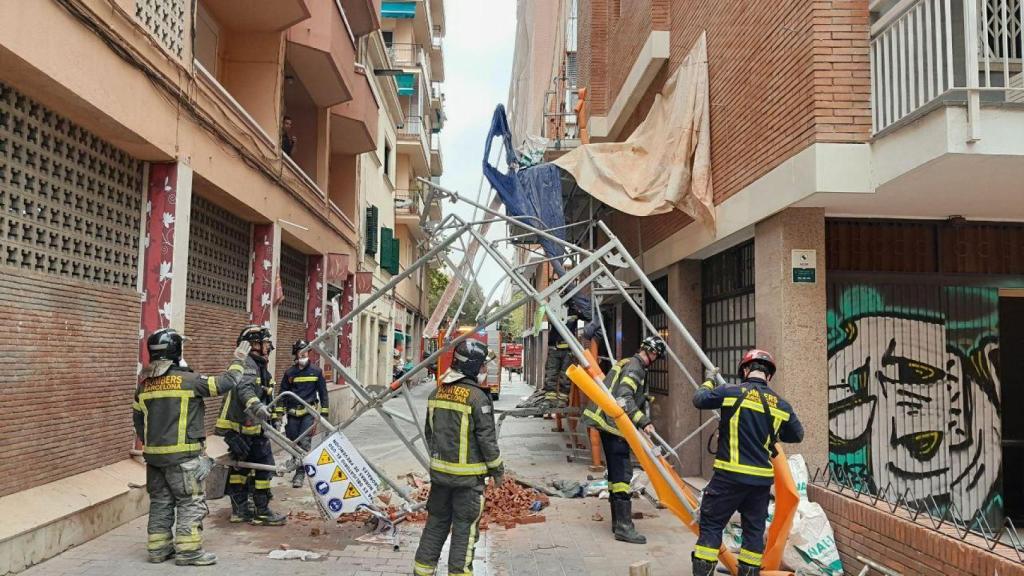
[554,34,715,229]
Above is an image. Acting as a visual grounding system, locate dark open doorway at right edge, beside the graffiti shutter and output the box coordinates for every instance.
[997,290,1024,524]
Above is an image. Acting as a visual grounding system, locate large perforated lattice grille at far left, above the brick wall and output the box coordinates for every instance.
[0,83,142,288]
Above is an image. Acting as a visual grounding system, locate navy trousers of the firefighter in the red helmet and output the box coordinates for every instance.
[694,471,771,567]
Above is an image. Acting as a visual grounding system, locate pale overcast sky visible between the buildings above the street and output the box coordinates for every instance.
[440,0,516,307]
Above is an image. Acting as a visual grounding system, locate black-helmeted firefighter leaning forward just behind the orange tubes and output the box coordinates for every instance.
[583,336,667,544]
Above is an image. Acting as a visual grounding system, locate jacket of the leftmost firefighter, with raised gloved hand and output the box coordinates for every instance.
[132,362,243,466]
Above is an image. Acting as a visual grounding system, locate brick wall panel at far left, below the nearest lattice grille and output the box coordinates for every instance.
[0,268,141,496]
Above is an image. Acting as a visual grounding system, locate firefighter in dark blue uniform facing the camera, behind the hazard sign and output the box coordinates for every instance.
[274,340,330,488]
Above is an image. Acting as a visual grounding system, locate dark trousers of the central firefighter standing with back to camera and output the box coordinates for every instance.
[413,484,483,576]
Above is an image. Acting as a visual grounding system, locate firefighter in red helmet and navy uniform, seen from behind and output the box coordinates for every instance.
[692,349,804,576]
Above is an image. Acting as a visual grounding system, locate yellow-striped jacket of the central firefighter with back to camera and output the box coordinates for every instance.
[424,377,505,487]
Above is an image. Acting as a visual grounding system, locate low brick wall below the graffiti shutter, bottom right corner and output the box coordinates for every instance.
[808,485,1024,576]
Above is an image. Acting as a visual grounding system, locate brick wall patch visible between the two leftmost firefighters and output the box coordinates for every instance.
[183,300,249,435]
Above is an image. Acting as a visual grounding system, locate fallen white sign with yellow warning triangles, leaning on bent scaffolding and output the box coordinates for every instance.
[302,431,381,520]
